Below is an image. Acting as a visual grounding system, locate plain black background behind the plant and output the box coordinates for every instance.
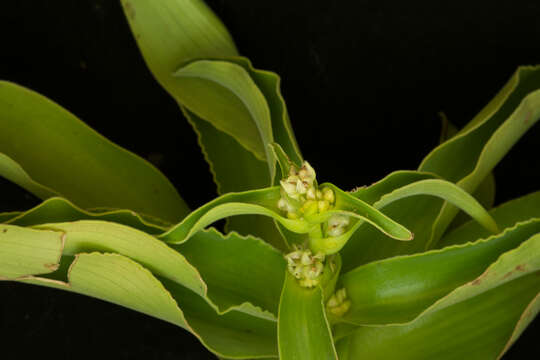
[0,0,540,359]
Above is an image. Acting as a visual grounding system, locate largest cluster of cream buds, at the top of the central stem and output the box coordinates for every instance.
[278,161,335,219]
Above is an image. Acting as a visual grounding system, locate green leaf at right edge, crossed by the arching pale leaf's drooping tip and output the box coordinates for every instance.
[437,191,540,248]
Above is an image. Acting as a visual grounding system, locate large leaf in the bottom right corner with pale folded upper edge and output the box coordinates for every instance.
[340,234,540,359]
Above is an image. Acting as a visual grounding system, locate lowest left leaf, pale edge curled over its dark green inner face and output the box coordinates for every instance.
[20,253,277,359]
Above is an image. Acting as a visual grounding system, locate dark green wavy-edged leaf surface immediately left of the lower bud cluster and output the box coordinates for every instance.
[173,228,286,316]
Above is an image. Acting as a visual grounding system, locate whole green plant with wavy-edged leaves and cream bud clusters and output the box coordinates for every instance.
[0,0,540,360]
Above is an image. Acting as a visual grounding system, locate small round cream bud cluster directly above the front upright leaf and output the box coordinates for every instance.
[285,248,324,288]
